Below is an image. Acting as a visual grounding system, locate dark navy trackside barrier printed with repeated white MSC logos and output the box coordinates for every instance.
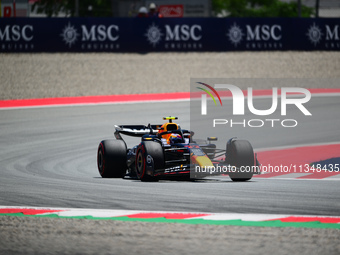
[0,18,340,52]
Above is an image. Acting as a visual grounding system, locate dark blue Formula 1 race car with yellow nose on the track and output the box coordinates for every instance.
[97,117,260,181]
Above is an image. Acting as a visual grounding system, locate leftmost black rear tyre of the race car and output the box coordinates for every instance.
[97,140,127,178]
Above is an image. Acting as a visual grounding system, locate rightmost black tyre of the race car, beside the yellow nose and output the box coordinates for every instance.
[227,140,255,182]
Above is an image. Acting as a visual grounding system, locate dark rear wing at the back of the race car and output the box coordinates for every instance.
[115,124,162,139]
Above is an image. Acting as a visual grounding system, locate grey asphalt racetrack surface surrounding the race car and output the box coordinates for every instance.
[0,97,340,215]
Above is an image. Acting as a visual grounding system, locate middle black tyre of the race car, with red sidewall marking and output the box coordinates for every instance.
[136,141,164,181]
